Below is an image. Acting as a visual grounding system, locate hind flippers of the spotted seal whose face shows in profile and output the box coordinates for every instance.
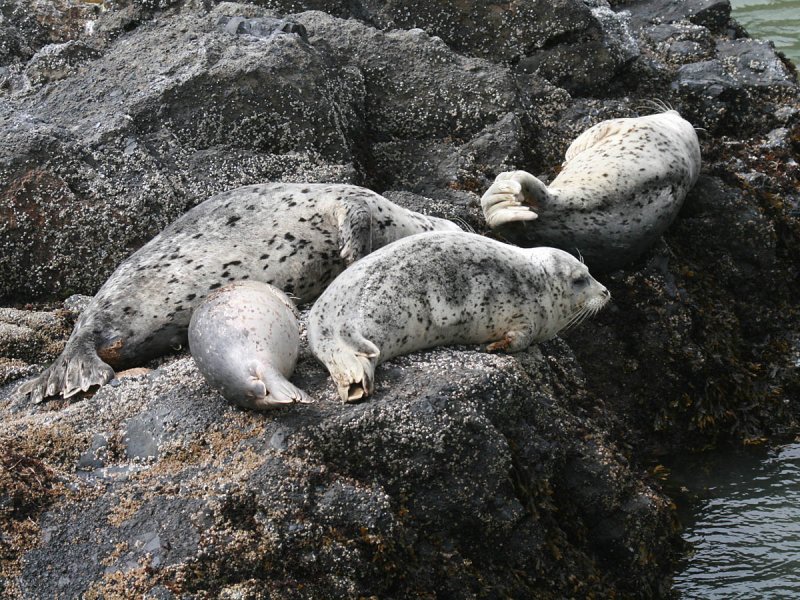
[324,336,381,402]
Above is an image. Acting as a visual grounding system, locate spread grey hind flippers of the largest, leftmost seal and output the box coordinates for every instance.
[17,337,114,404]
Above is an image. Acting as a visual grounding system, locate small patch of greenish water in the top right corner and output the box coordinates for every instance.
[731,0,800,65]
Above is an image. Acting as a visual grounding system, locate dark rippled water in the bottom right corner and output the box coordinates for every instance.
[671,444,800,600]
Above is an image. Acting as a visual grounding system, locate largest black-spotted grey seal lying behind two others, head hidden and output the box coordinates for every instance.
[18,183,460,402]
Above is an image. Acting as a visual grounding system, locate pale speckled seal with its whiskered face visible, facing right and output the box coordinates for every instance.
[308,232,610,401]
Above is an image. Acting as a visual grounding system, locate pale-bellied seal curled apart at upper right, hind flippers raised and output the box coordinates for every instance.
[481,110,700,270]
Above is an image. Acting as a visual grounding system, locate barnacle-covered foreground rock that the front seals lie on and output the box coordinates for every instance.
[0,343,680,598]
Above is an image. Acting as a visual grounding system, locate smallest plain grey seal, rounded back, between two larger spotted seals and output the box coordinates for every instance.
[189,281,311,410]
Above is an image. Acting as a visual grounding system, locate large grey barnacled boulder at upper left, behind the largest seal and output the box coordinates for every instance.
[0,7,363,294]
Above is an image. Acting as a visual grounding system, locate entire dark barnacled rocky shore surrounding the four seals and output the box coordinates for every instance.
[0,0,800,598]
